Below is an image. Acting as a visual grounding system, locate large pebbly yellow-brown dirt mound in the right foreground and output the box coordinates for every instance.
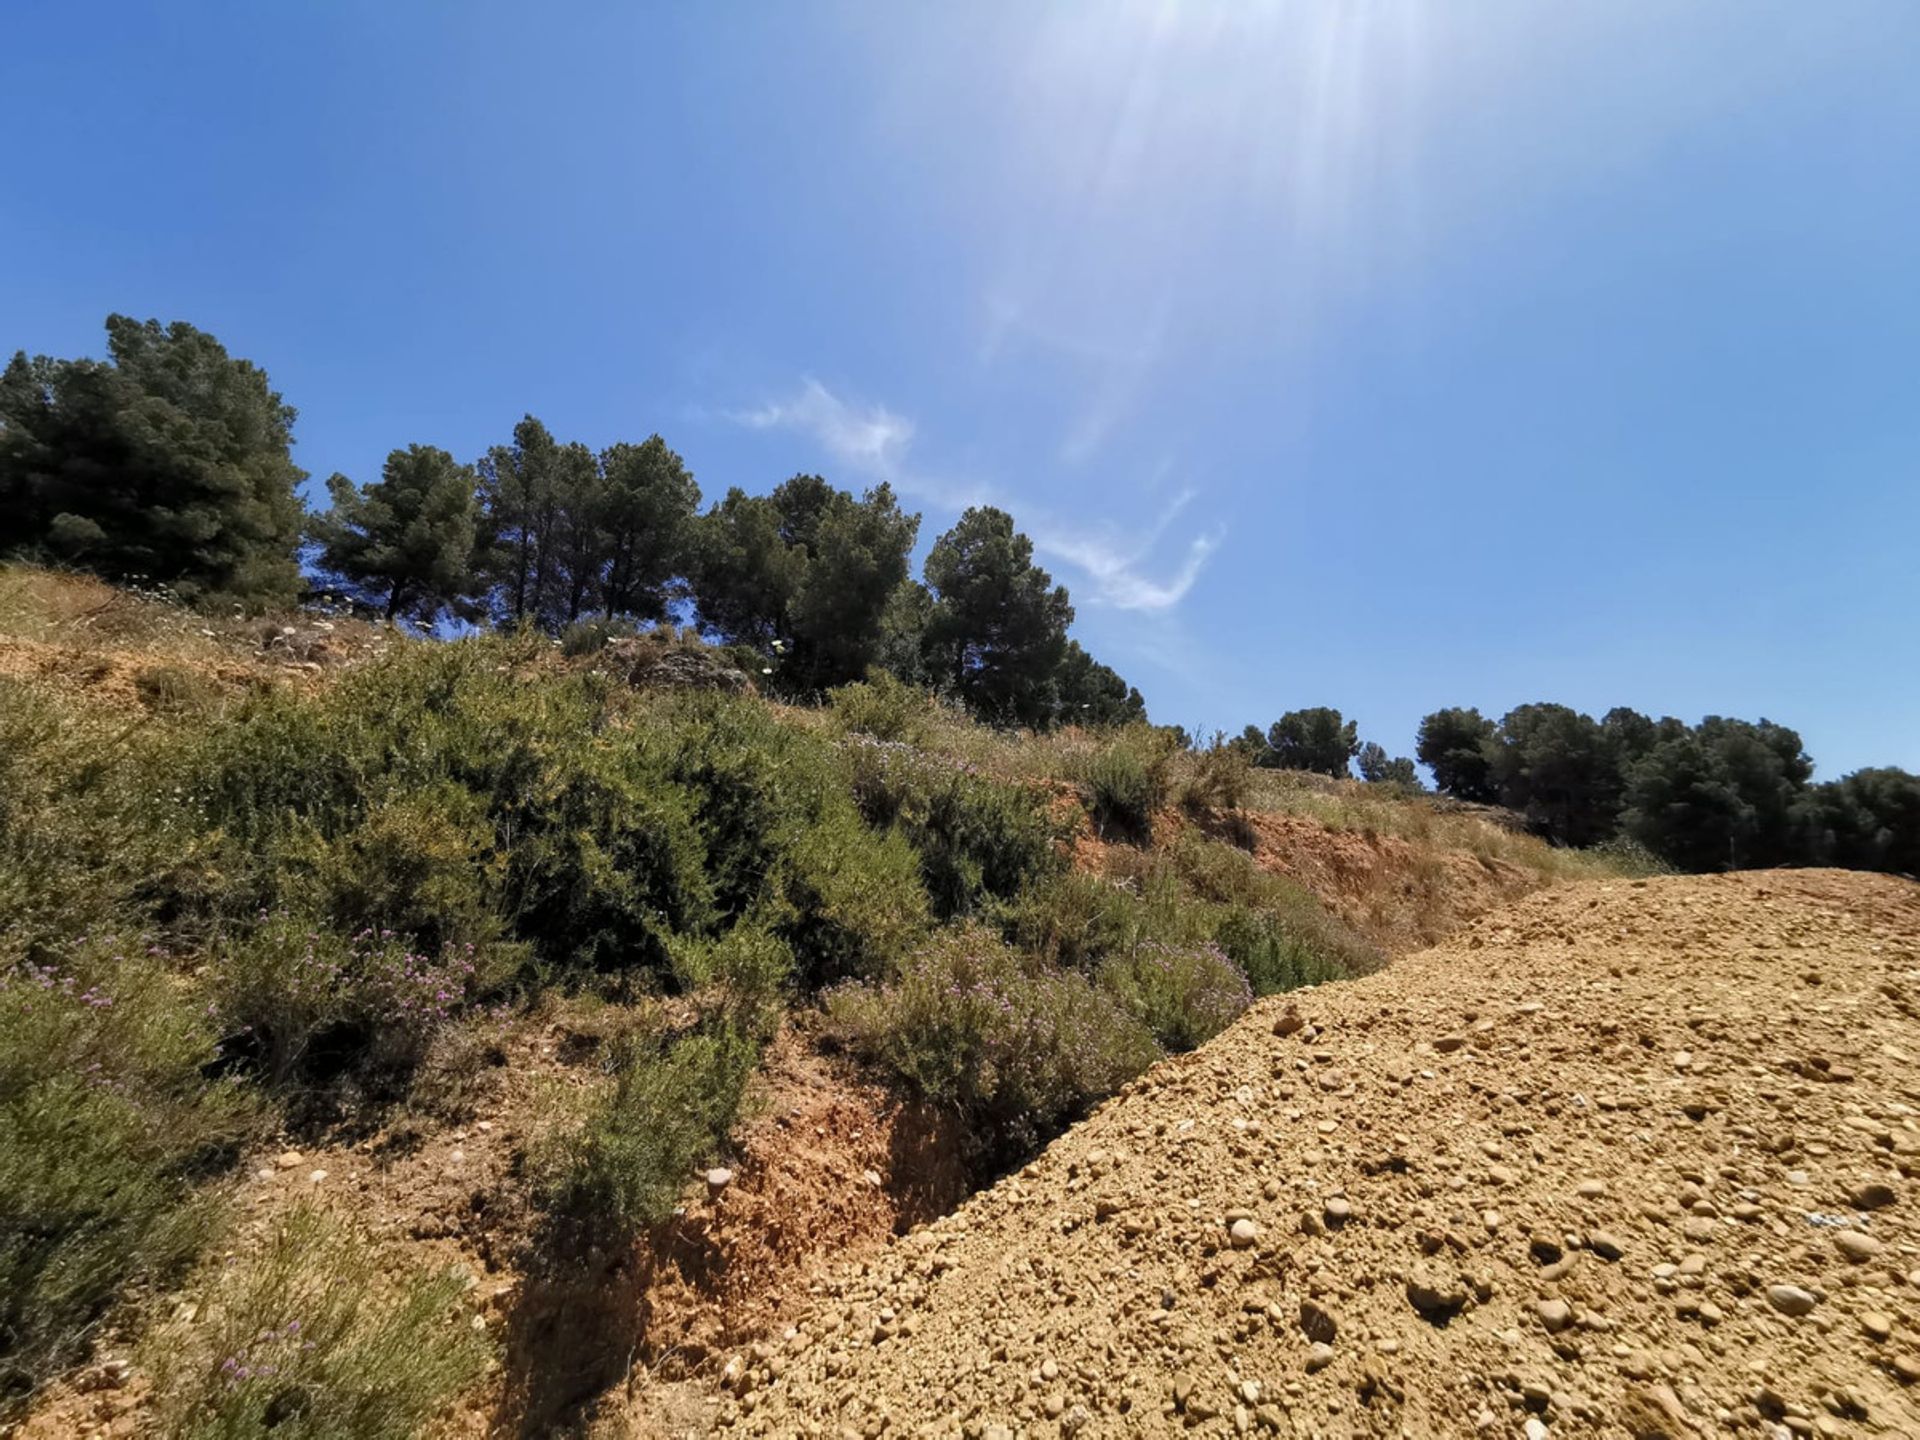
[722,872,1920,1436]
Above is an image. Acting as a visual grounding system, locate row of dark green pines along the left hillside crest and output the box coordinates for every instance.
[0,315,1146,728]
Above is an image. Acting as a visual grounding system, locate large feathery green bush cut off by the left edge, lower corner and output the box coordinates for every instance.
[0,939,250,1415]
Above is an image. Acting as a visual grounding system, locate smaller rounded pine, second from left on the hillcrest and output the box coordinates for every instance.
[311,445,480,624]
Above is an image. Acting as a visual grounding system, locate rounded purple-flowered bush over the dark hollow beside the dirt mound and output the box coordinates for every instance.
[828,925,1160,1162]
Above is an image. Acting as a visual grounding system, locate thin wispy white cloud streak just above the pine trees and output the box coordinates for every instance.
[730,376,1221,611]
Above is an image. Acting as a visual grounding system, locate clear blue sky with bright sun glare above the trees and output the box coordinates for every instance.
[0,0,1920,776]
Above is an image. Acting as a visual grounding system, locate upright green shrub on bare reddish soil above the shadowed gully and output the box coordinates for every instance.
[534,1020,758,1236]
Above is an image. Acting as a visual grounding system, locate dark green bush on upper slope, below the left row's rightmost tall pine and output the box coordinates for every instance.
[849,743,1066,920]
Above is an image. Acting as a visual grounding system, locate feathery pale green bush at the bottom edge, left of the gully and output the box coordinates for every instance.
[156,1206,488,1440]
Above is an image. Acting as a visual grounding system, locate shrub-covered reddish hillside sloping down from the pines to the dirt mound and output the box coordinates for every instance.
[0,566,1666,1436]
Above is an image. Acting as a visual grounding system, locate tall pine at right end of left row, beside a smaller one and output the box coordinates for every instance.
[925,505,1073,728]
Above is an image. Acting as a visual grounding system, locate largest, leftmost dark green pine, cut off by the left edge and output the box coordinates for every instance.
[0,315,305,605]
